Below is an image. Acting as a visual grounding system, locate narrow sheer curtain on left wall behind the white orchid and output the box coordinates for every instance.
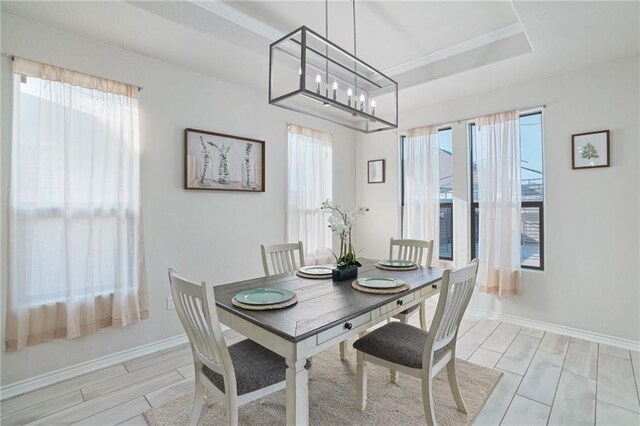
[287,124,332,265]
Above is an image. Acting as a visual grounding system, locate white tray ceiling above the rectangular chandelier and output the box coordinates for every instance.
[2,0,640,110]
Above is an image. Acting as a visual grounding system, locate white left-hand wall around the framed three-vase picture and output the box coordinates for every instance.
[0,13,355,385]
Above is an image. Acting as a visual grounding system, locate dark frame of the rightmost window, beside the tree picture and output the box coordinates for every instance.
[466,109,546,271]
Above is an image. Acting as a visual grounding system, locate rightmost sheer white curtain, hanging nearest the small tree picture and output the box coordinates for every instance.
[476,111,522,296]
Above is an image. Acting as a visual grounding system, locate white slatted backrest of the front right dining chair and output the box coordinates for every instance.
[424,259,478,360]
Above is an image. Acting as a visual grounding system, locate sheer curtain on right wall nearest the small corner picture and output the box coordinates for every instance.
[403,126,440,259]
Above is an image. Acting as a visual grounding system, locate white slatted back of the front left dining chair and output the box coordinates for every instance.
[169,269,233,376]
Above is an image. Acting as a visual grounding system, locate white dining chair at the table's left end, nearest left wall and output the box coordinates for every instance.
[169,268,309,425]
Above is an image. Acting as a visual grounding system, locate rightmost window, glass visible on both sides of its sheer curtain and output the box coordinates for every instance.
[469,112,544,270]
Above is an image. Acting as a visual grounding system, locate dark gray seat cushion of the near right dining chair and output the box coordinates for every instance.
[353,321,448,368]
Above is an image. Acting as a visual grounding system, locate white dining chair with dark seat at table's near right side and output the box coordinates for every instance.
[353,259,478,425]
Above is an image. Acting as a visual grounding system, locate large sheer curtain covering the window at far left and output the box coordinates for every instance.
[5,58,148,351]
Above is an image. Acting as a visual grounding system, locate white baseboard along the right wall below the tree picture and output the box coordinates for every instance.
[467,306,640,351]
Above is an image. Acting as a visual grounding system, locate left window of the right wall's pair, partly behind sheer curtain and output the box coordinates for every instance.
[400,127,453,260]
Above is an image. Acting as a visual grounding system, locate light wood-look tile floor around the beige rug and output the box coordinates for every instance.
[0,305,640,426]
